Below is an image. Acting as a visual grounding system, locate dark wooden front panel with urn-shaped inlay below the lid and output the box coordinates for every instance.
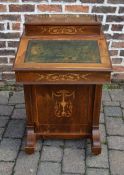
[32,85,93,134]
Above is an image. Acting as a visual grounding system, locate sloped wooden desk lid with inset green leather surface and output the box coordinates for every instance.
[14,36,111,71]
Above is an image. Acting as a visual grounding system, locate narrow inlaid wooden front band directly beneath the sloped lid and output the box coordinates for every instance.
[16,71,110,84]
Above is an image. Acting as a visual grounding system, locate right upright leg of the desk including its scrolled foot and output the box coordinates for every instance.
[92,85,102,155]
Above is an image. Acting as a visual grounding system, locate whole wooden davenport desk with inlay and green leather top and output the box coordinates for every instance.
[14,15,112,154]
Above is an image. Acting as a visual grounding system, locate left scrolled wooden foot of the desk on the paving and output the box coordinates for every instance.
[25,127,36,154]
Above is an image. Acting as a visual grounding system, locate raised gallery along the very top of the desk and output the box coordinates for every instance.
[25,14,100,25]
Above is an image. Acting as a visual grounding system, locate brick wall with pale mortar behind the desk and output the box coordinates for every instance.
[0,0,124,81]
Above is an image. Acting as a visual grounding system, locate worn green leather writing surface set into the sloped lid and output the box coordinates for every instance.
[25,40,100,63]
